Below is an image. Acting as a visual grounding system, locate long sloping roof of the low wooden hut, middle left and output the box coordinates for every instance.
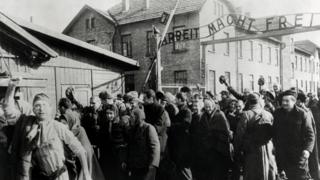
[8,15,139,69]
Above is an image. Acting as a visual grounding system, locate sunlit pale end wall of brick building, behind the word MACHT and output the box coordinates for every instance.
[199,0,237,94]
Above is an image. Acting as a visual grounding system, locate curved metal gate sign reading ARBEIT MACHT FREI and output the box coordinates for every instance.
[162,13,320,45]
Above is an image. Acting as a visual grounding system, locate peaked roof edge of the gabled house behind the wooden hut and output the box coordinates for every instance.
[62,5,117,34]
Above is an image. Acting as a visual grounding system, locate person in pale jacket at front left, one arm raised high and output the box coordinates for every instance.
[4,81,92,180]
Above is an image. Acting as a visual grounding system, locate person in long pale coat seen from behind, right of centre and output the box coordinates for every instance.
[234,93,277,180]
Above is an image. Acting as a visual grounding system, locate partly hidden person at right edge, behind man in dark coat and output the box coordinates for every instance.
[297,92,320,180]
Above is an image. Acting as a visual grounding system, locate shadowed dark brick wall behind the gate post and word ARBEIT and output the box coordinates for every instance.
[114,13,200,90]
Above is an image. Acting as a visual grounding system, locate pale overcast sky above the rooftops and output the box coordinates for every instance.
[0,0,320,46]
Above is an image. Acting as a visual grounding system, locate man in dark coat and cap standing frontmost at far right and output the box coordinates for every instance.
[273,90,315,180]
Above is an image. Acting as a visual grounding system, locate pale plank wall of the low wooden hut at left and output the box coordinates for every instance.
[0,41,124,112]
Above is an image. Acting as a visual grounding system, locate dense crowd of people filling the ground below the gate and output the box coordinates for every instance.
[0,77,320,180]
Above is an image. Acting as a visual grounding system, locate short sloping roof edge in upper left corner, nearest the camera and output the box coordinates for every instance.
[0,12,58,57]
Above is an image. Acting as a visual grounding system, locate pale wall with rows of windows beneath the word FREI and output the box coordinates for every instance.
[237,39,280,91]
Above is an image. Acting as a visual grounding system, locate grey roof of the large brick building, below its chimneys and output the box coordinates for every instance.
[107,0,234,25]
